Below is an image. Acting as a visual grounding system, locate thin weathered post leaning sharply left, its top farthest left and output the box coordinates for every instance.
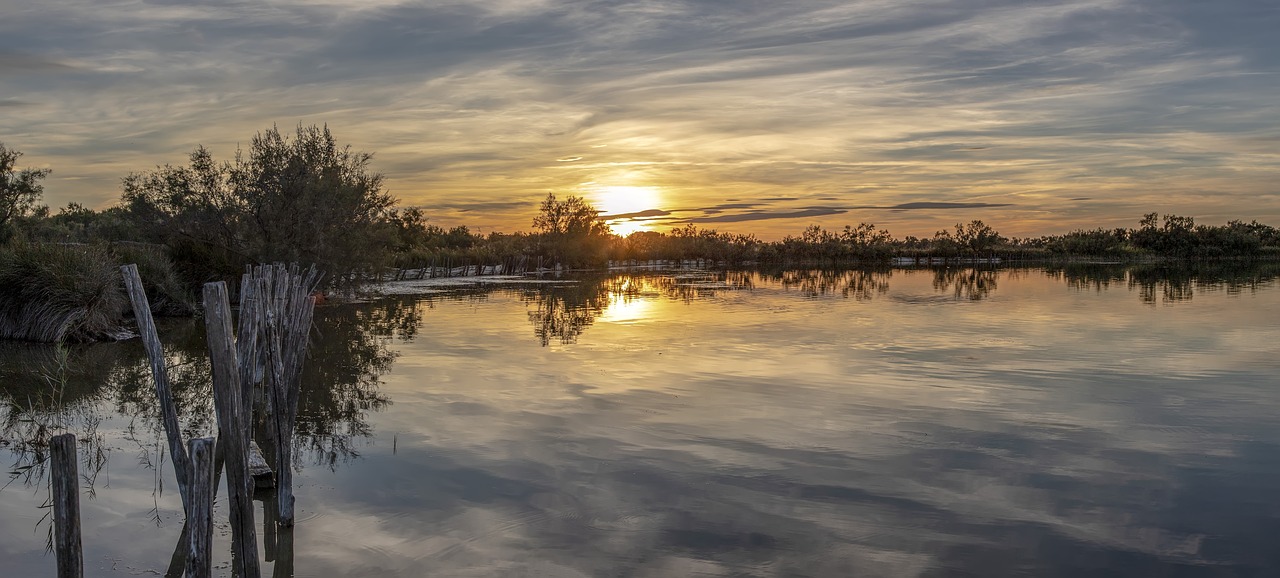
[120,265,191,512]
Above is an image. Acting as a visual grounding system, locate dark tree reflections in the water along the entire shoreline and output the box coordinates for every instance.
[0,261,1280,483]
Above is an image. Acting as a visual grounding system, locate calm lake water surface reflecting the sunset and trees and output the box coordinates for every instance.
[0,263,1280,577]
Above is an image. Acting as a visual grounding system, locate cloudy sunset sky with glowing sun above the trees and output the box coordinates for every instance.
[0,0,1280,239]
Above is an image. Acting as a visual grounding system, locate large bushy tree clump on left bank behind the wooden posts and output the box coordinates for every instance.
[122,125,396,289]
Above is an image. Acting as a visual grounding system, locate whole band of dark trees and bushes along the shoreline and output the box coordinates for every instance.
[0,124,1280,338]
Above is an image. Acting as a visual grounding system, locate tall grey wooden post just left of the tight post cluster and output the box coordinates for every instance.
[204,281,261,578]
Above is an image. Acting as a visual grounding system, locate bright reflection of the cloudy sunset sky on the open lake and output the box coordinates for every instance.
[330,269,1280,577]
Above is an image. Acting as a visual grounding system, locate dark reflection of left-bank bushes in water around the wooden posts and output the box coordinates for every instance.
[0,301,409,491]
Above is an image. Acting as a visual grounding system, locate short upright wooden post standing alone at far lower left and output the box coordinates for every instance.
[49,434,84,578]
